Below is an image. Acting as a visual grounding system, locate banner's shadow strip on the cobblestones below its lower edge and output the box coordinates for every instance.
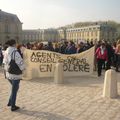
[23,76,104,87]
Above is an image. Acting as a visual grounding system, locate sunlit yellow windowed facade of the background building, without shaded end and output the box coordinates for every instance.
[66,26,100,42]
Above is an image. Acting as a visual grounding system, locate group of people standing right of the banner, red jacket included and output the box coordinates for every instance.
[95,40,120,76]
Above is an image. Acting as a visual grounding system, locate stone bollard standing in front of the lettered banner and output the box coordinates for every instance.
[54,63,64,84]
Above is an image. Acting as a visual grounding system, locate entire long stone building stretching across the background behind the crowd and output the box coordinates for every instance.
[22,24,119,43]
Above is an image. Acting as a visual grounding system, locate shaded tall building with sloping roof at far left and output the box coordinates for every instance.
[0,10,22,44]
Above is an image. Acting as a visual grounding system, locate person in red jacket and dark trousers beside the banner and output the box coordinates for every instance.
[95,43,108,76]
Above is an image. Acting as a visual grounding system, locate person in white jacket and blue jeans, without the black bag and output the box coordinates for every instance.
[3,39,25,111]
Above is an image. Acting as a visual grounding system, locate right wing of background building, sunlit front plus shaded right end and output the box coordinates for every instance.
[58,24,118,42]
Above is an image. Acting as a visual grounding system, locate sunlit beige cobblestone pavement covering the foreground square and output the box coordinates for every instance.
[0,67,120,120]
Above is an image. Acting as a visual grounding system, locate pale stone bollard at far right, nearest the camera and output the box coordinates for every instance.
[103,69,118,98]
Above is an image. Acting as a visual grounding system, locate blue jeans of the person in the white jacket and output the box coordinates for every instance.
[8,80,20,107]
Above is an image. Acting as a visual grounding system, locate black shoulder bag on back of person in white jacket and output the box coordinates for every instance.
[8,51,22,75]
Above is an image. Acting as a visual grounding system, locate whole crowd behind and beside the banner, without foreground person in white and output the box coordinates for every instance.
[0,40,120,76]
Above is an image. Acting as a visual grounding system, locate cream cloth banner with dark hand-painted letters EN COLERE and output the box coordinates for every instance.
[24,47,94,78]
